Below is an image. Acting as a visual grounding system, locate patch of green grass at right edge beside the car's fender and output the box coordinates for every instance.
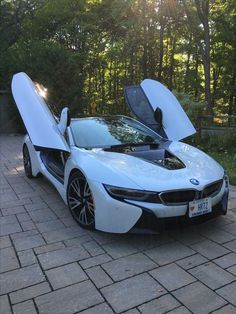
[207,152,236,185]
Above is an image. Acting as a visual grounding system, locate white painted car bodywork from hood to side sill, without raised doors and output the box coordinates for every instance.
[26,132,225,233]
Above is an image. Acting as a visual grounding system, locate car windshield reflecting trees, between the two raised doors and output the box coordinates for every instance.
[71,116,161,148]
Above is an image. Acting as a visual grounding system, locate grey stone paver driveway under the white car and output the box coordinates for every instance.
[0,136,236,314]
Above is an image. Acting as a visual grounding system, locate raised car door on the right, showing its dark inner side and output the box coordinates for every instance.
[125,79,196,141]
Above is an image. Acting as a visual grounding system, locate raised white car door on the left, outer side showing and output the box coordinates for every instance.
[12,72,70,152]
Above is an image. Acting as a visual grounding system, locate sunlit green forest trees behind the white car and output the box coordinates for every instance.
[0,0,236,183]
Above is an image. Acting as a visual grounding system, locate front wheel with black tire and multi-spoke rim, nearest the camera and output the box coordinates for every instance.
[67,171,95,230]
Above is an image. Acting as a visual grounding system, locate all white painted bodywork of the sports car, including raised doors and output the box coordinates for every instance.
[12,73,226,233]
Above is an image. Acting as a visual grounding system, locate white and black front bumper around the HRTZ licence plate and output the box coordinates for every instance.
[88,180,228,233]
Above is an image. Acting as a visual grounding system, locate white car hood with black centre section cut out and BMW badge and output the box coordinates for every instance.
[86,142,224,191]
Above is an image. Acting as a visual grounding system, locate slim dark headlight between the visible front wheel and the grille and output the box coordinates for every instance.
[104,184,161,203]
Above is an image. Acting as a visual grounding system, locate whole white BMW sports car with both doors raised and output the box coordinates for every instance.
[12,73,229,233]
